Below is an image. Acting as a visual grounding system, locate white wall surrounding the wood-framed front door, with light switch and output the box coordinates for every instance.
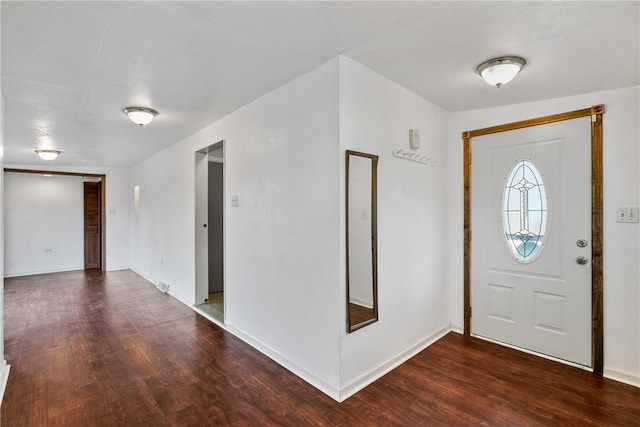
[445,87,640,385]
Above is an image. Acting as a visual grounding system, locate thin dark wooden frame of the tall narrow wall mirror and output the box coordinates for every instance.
[345,150,378,333]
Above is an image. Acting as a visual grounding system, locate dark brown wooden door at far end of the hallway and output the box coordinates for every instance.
[84,182,102,270]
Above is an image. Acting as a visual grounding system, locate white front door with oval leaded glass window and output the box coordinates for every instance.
[471,117,592,366]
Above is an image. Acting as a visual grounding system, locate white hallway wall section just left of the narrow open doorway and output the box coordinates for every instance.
[131,144,197,304]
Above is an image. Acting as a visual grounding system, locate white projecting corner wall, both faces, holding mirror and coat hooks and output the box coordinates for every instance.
[132,58,450,400]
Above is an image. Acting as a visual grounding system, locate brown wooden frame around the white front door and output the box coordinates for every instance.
[462,104,604,376]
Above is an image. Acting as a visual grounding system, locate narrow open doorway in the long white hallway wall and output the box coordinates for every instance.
[195,141,225,323]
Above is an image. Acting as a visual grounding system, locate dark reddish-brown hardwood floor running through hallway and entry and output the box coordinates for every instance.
[0,271,640,427]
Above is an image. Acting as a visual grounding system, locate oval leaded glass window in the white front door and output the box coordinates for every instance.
[502,160,548,263]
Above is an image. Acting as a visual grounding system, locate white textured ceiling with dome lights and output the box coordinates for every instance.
[0,1,640,166]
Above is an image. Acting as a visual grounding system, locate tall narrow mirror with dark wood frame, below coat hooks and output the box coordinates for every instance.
[345,150,378,332]
